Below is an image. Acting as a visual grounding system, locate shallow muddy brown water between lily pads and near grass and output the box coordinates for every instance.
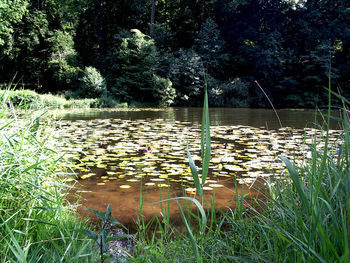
[70,180,266,232]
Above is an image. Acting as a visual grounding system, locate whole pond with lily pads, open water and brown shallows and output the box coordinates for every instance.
[58,108,340,224]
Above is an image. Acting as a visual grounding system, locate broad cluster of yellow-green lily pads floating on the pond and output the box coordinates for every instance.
[54,119,340,193]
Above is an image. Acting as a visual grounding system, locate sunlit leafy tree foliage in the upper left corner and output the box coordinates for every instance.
[0,0,85,91]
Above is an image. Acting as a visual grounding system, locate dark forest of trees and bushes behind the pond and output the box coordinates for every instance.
[0,0,350,108]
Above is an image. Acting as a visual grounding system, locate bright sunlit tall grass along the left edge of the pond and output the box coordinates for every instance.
[0,86,95,262]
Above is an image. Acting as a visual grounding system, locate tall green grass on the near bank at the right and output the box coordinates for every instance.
[132,86,350,263]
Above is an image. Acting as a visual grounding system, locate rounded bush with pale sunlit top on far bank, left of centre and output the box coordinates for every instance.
[111,29,175,105]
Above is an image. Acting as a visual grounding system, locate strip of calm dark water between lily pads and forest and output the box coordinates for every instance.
[63,108,338,129]
